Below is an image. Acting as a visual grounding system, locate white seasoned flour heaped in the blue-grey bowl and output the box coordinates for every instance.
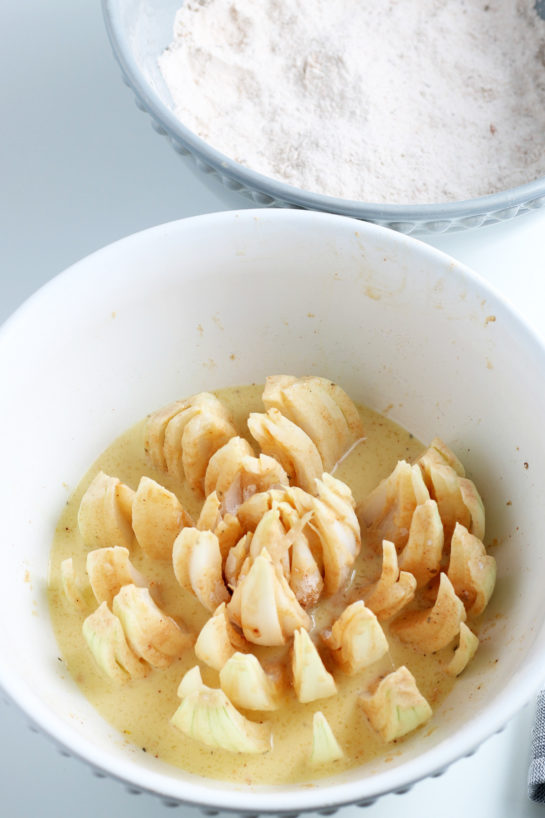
[159,0,545,203]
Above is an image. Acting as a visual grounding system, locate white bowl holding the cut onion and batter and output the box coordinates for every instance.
[0,210,545,814]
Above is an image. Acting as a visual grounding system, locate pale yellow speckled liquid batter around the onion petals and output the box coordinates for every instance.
[50,385,453,784]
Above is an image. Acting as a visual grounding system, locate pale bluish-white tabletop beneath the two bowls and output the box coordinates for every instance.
[0,0,545,818]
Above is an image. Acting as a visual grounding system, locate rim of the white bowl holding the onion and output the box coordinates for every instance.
[0,209,545,815]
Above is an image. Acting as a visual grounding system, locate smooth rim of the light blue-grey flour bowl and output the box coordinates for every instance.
[101,0,545,226]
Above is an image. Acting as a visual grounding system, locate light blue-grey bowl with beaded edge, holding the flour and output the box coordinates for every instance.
[103,0,545,234]
